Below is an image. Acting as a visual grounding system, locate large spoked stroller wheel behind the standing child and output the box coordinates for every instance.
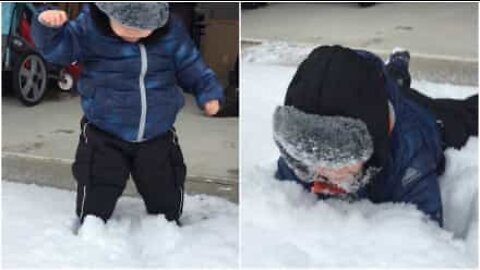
[12,52,47,106]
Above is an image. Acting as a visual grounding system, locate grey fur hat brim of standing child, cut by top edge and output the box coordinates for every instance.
[95,2,169,30]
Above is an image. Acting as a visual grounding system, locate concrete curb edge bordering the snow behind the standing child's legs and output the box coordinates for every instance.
[2,152,238,204]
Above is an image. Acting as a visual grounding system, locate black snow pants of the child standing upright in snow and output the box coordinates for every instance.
[72,118,186,222]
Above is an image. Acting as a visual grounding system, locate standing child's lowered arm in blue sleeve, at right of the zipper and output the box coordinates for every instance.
[171,17,224,115]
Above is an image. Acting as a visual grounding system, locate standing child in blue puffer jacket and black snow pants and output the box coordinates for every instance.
[32,2,223,226]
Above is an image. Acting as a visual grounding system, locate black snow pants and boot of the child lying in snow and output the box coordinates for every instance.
[386,60,478,149]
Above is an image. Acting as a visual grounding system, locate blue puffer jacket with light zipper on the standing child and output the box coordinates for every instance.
[32,5,223,142]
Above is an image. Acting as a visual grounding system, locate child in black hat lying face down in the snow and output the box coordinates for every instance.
[274,46,478,225]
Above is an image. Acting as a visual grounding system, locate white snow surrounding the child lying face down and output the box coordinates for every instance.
[240,47,478,267]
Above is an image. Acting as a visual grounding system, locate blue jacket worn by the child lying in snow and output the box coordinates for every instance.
[276,51,444,226]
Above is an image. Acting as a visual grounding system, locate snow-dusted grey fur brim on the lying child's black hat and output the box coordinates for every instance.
[273,106,373,180]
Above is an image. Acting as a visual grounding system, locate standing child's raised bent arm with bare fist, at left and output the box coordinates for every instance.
[32,5,85,65]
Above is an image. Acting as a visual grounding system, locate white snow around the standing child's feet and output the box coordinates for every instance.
[2,181,238,268]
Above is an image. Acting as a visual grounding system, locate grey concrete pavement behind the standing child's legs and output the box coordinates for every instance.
[2,90,238,202]
